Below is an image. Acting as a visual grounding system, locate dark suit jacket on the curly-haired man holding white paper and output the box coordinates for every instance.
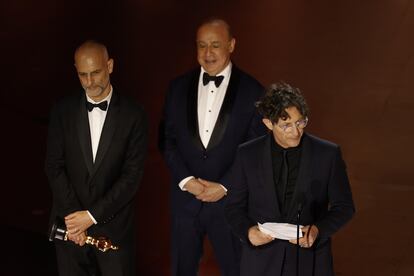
[226,133,354,275]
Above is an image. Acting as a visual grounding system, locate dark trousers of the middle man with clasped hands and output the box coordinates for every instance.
[171,203,241,276]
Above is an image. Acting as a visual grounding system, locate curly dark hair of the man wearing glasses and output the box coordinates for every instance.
[256,82,309,123]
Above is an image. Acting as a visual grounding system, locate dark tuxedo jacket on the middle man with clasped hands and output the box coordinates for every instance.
[161,64,265,216]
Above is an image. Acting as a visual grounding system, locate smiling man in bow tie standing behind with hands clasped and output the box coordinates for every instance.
[160,18,265,276]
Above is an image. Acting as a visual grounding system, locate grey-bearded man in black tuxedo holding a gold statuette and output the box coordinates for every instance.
[46,41,147,276]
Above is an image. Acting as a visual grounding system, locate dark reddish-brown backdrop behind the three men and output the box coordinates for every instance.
[0,0,414,276]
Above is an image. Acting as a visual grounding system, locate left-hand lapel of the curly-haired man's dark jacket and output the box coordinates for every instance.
[260,134,280,217]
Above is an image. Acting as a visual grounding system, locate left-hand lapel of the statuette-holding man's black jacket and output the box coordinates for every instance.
[76,92,93,175]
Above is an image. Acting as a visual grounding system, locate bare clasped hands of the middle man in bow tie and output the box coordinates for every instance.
[184,178,226,202]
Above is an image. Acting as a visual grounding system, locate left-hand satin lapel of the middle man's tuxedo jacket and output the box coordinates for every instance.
[187,68,205,150]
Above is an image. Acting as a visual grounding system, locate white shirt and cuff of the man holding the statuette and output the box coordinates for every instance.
[86,86,112,224]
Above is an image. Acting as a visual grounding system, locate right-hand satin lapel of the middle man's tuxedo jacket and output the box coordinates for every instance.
[207,65,240,150]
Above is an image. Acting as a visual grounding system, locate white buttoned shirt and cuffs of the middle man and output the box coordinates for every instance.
[178,62,232,192]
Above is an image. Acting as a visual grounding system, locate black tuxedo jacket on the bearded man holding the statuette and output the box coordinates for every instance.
[46,90,147,246]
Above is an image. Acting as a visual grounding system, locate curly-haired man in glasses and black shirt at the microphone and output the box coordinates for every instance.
[226,83,355,276]
